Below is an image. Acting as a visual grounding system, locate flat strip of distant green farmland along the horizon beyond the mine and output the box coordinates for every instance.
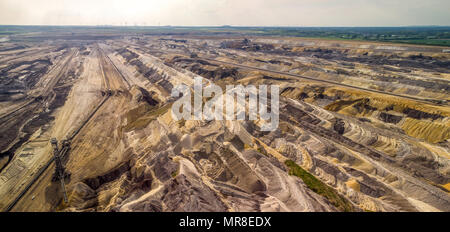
[0,26,450,47]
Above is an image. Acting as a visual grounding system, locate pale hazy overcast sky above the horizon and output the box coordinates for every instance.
[0,0,450,26]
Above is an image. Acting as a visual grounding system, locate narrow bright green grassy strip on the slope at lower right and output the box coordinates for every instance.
[285,160,353,212]
